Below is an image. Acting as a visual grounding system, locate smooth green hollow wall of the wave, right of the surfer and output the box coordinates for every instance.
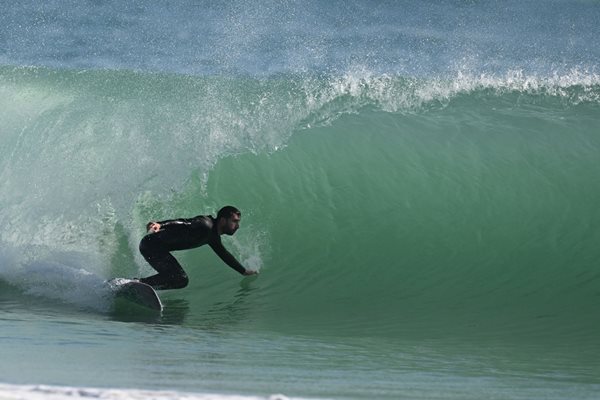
[197,98,600,342]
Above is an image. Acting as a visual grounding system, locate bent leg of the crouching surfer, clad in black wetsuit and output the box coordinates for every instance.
[140,235,189,290]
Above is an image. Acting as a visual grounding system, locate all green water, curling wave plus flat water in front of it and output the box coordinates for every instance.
[0,68,600,399]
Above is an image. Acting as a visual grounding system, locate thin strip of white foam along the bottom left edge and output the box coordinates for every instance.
[0,384,316,400]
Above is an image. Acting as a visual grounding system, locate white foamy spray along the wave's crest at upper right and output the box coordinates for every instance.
[324,67,600,113]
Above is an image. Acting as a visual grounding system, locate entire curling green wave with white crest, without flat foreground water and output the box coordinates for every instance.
[0,66,600,342]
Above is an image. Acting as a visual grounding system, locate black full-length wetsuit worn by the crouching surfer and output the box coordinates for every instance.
[140,215,246,290]
